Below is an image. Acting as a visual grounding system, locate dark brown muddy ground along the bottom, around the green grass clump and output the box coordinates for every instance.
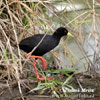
[0,73,100,100]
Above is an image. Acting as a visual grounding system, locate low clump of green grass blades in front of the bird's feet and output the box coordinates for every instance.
[30,68,77,98]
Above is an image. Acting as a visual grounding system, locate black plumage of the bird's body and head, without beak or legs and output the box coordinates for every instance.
[19,27,68,56]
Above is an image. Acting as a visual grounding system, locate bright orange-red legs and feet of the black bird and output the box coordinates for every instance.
[26,53,52,81]
